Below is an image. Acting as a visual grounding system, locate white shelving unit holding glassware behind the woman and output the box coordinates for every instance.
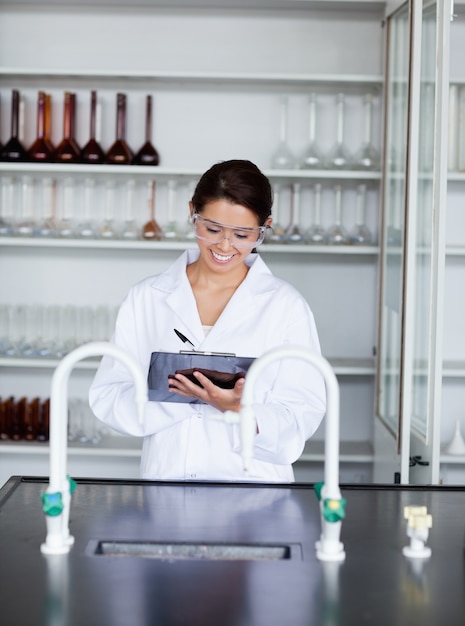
[0,0,384,481]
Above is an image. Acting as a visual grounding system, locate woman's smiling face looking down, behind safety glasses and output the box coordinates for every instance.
[191,199,268,271]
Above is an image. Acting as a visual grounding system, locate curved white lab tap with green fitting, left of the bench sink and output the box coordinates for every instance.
[41,341,148,554]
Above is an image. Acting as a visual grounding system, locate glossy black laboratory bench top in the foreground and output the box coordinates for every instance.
[0,477,465,626]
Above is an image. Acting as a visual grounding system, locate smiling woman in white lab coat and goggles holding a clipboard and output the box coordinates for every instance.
[90,160,326,482]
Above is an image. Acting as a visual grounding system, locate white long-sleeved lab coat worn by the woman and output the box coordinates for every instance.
[89,250,326,482]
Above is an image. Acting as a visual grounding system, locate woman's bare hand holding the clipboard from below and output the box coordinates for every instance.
[168,372,245,412]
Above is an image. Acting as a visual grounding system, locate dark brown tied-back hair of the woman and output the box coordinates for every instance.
[192,159,273,226]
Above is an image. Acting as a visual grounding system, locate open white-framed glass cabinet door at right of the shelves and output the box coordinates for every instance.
[375,0,450,483]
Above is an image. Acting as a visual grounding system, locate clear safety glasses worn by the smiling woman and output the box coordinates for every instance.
[192,213,266,249]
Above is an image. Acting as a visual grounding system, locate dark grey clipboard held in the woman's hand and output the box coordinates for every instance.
[147,350,255,404]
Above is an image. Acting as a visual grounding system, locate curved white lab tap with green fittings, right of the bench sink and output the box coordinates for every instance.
[225,346,345,561]
